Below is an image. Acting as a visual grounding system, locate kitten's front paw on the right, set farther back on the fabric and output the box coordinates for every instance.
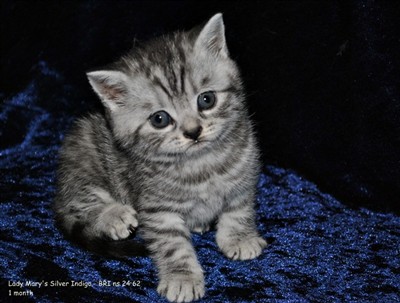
[218,236,267,260]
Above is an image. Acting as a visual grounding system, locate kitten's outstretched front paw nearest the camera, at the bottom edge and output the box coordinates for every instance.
[157,274,204,302]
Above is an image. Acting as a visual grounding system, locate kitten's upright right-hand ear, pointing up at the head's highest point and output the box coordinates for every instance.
[195,13,229,57]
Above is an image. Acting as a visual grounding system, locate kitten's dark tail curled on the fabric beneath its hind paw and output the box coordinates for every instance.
[62,223,149,259]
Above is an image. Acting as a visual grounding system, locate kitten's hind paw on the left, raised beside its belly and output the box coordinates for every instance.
[96,204,138,240]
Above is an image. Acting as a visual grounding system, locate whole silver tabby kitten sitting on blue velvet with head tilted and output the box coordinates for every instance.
[55,14,266,302]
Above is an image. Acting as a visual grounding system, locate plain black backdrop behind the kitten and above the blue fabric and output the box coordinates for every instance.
[0,0,400,212]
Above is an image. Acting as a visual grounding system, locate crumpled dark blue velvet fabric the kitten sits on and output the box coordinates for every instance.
[0,61,400,303]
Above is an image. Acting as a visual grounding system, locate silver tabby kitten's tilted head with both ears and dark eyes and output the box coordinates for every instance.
[88,14,245,157]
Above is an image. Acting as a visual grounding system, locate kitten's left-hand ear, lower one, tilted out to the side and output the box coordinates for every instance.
[86,70,128,111]
